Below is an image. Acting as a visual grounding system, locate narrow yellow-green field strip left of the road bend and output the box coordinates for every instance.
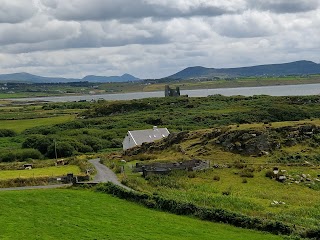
[0,165,80,180]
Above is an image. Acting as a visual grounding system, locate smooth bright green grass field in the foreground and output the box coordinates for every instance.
[0,189,282,240]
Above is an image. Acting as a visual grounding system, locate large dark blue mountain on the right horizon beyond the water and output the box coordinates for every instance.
[167,61,320,79]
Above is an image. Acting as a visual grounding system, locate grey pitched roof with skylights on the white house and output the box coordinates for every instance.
[128,127,170,145]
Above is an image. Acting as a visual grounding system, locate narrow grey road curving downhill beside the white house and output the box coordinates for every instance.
[89,158,132,190]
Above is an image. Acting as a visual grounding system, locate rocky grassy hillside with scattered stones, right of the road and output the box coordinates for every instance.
[106,121,320,232]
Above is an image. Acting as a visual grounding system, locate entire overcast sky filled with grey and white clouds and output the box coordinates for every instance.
[0,0,320,78]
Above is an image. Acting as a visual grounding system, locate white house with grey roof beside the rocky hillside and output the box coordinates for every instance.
[122,126,170,150]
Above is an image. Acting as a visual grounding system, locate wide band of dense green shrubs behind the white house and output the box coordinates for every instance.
[4,95,320,161]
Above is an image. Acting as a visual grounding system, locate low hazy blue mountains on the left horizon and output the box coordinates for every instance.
[0,72,140,83]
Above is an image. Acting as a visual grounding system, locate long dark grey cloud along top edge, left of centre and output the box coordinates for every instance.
[42,0,234,21]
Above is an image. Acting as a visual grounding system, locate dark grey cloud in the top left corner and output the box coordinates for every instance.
[0,0,38,23]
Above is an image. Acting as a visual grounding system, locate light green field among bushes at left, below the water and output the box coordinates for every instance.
[0,115,75,132]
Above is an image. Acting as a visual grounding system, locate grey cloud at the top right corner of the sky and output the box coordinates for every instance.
[248,0,319,13]
